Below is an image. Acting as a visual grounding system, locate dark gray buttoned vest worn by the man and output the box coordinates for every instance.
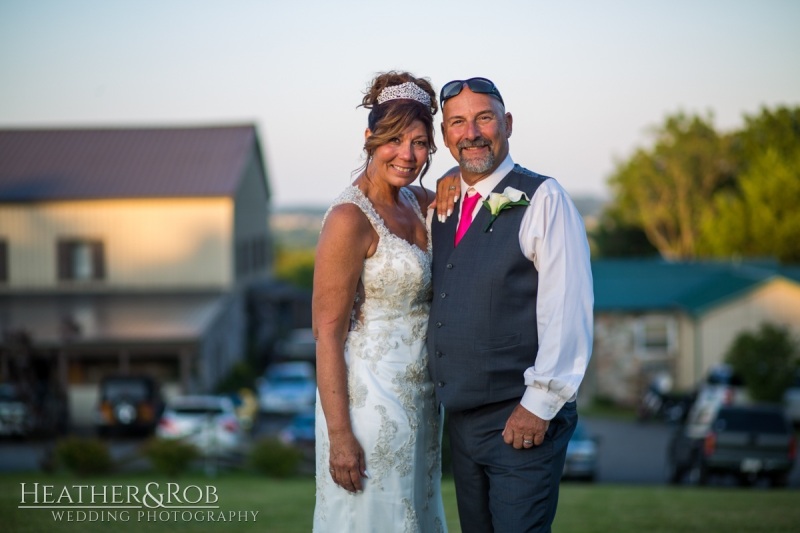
[427,165,548,411]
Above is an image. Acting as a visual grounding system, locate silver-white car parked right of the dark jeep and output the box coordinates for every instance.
[156,395,244,456]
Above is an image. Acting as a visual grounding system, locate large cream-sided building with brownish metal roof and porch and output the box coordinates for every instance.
[0,124,273,424]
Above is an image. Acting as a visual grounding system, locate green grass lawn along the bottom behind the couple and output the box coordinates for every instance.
[0,473,800,533]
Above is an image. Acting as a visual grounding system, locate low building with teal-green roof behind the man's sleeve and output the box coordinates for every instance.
[586,259,800,404]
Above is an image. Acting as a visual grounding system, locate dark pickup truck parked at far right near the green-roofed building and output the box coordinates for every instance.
[667,405,797,487]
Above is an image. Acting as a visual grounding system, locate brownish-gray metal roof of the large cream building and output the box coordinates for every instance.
[0,125,267,202]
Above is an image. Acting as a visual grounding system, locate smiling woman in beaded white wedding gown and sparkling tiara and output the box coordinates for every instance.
[312,72,447,533]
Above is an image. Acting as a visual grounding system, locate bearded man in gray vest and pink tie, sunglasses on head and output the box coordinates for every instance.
[427,78,593,533]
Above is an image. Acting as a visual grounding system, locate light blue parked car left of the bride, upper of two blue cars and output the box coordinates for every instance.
[258,361,317,414]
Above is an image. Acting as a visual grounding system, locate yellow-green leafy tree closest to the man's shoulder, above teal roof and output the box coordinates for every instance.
[609,113,734,259]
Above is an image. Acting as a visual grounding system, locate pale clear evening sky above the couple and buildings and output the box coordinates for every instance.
[0,0,800,207]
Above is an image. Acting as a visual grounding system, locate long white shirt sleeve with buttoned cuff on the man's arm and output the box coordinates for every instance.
[519,179,594,420]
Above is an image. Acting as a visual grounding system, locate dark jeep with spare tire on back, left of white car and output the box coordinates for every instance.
[96,375,164,435]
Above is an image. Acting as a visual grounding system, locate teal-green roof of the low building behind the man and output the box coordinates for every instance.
[592,259,800,316]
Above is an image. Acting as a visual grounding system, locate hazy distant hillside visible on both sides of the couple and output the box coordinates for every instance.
[270,196,606,248]
